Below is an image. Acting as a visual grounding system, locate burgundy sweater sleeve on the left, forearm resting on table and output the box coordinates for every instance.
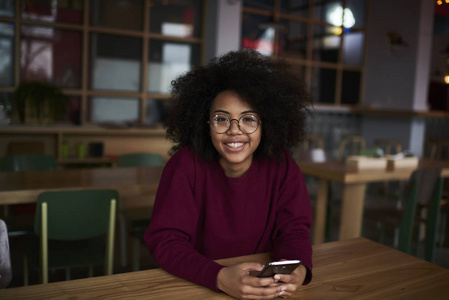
[145,150,223,292]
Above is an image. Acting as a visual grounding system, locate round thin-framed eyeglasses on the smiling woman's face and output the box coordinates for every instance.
[207,115,262,134]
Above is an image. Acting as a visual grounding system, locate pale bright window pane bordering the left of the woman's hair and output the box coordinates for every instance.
[148,40,200,93]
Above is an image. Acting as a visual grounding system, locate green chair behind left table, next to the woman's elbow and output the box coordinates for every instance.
[116,153,165,271]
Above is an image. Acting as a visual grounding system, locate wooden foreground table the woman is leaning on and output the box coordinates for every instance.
[0,238,449,300]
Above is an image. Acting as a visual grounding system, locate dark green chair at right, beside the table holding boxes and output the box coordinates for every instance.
[365,169,443,261]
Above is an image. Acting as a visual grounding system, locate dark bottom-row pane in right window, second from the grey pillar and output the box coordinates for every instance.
[311,68,337,103]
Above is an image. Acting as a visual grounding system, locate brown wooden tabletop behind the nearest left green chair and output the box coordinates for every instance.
[0,167,163,205]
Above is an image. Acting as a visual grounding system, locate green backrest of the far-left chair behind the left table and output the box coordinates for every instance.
[0,154,56,172]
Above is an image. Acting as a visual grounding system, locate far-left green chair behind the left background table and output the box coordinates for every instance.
[0,154,56,237]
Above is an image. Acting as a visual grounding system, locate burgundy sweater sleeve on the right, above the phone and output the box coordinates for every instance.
[273,154,312,285]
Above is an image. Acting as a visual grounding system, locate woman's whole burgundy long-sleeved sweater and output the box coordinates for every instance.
[145,147,312,291]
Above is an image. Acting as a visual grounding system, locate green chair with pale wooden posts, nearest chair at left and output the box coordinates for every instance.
[23,190,119,285]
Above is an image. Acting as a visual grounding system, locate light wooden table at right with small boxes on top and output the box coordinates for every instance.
[298,160,449,244]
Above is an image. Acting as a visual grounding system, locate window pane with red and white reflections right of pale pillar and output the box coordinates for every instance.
[242,13,275,55]
